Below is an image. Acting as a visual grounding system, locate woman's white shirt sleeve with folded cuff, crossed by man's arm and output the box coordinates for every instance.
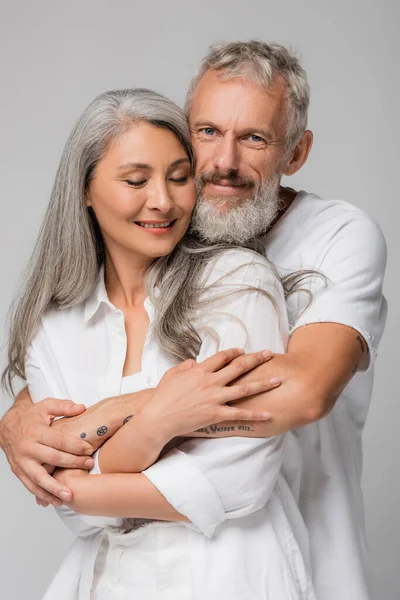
[143,252,288,537]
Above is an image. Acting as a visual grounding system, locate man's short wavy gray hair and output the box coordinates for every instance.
[185,40,310,152]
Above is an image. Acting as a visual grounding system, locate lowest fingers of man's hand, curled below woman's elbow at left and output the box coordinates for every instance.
[20,461,72,506]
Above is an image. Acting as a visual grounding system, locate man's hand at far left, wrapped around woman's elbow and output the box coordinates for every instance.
[0,391,93,506]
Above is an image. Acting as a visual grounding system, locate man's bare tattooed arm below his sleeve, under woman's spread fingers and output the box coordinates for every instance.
[192,323,368,437]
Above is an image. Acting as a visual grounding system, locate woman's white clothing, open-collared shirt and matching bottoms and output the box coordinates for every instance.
[26,251,315,600]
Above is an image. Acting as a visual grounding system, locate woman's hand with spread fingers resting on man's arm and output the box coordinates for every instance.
[140,348,279,444]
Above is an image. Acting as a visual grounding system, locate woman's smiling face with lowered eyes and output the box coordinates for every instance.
[86,123,195,262]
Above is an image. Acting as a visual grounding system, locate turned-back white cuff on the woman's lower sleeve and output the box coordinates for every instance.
[143,449,226,537]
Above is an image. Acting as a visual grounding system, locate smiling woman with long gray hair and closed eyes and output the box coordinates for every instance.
[3,90,314,600]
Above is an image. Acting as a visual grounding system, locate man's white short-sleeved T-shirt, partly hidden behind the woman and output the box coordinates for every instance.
[265,192,387,600]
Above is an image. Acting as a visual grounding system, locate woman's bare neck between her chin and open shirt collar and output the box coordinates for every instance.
[105,249,154,310]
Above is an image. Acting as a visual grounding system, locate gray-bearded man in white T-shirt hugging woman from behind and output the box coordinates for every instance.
[0,42,386,600]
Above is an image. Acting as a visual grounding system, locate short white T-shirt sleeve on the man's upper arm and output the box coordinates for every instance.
[292,216,387,369]
